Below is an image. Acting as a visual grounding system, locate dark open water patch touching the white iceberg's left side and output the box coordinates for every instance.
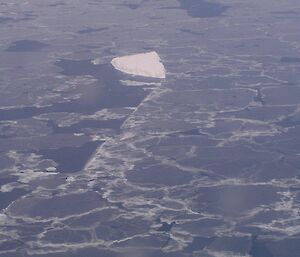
[0,60,147,120]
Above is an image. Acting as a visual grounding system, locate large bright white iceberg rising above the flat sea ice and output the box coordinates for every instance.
[111,52,166,79]
